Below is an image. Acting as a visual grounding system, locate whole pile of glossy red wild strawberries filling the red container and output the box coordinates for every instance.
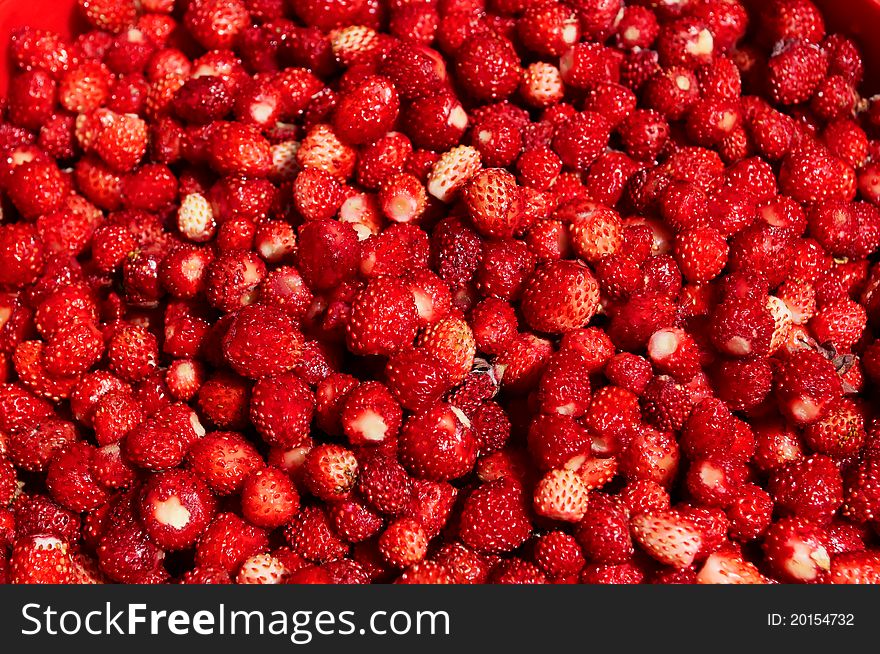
[0,0,880,583]
